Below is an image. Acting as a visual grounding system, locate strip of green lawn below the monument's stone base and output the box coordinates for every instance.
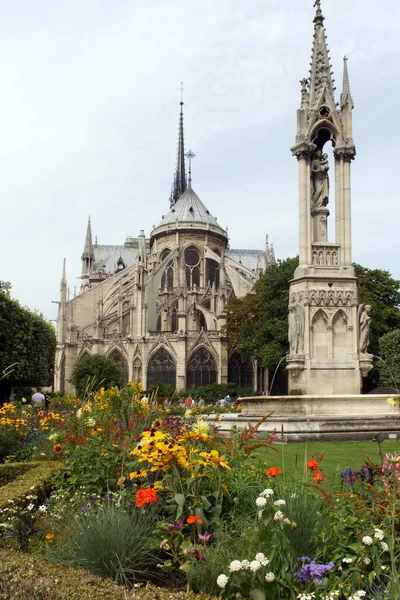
[260,440,400,486]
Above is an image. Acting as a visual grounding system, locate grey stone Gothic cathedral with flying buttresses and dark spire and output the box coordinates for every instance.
[54,101,275,392]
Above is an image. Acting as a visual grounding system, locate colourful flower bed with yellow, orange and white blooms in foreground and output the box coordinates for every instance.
[0,384,400,600]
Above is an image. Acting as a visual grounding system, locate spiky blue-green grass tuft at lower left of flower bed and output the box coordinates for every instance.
[56,501,157,584]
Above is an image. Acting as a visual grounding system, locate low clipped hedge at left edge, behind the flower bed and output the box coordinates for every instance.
[0,461,63,509]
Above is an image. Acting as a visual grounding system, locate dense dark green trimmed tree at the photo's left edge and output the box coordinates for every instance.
[0,286,56,388]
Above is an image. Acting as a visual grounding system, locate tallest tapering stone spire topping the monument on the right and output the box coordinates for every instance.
[310,0,335,108]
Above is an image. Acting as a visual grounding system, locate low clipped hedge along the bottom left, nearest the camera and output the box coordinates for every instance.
[0,551,216,600]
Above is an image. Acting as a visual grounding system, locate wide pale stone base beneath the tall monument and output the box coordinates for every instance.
[209,394,400,442]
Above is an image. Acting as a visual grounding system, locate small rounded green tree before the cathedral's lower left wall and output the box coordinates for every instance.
[71,354,123,397]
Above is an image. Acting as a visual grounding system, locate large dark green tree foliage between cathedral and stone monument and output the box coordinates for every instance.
[226,257,299,369]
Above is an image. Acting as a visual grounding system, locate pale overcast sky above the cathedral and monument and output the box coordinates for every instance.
[0,0,400,319]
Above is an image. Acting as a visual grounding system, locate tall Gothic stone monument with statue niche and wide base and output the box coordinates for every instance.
[240,0,400,439]
